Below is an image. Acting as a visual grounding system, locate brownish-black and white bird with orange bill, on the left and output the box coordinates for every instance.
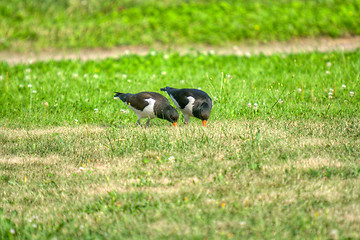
[114,92,179,127]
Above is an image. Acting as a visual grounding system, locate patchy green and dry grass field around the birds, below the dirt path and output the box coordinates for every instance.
[0,51,360,239]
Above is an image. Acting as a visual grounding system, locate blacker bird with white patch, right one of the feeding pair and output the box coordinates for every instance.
[160,87,213,127]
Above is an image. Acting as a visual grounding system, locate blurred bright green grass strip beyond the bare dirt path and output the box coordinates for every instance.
[0,0,360,51]
